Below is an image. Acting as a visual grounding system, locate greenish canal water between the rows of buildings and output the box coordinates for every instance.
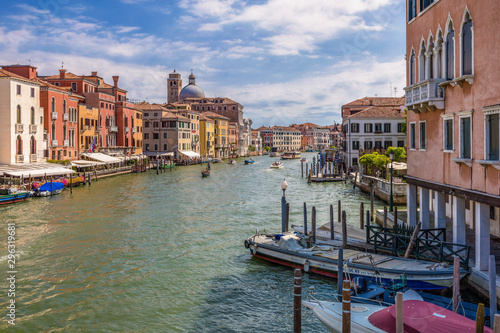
[0,153,388,332]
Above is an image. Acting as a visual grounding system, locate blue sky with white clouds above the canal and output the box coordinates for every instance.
[0,0,405,128]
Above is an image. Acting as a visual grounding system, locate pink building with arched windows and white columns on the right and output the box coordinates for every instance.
[405,0,500,270]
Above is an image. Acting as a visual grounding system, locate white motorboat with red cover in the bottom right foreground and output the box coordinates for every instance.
[302,293,493,333]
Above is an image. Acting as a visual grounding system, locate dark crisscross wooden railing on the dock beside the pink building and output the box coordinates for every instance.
[366,225,470,270]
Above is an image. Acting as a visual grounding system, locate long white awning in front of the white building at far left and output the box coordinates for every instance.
[0,163,75,178]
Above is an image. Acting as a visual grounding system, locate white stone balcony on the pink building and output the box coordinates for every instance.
[404,79,445,112]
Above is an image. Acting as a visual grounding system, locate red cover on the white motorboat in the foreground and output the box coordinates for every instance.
[368,300,493,333]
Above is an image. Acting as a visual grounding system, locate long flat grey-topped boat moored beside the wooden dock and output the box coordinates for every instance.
[244,232,468,290]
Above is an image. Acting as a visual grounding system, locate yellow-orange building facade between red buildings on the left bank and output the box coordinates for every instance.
[78,104,99,154]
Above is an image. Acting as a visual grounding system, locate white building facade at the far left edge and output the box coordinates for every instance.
[0,70,46,164]
